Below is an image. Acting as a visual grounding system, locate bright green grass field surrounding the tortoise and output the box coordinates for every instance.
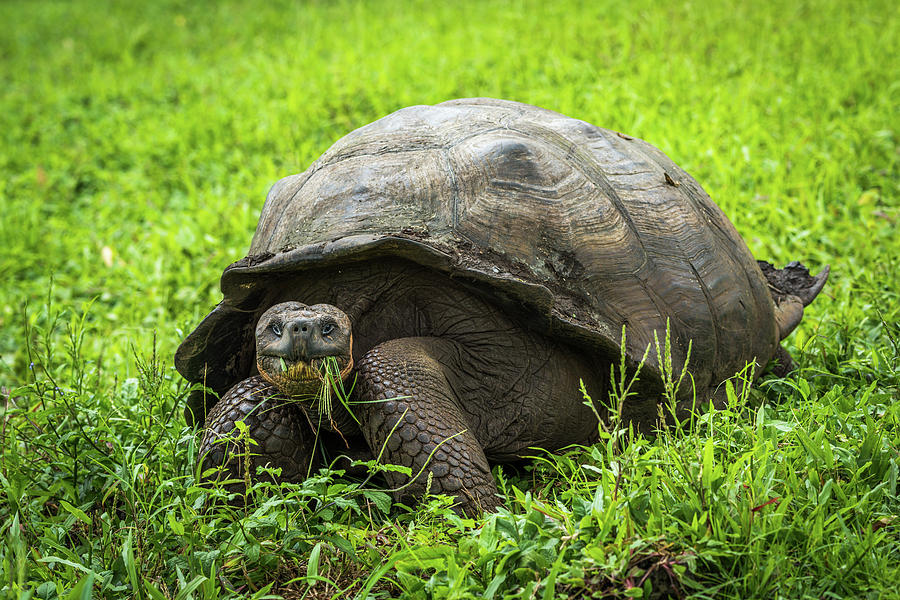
[0,0,900,600]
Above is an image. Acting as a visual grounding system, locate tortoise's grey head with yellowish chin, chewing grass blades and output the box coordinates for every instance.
[256,302,353,397]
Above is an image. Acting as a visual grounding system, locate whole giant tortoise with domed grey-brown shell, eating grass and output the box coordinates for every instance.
[175,98,828,513]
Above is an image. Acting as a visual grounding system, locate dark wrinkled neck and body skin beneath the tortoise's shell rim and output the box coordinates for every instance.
[253,259,609,459]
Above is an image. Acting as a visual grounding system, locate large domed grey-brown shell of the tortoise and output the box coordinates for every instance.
[176,98,778,424]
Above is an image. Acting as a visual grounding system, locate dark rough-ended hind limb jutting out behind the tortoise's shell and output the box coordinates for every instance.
[756,260,830,340]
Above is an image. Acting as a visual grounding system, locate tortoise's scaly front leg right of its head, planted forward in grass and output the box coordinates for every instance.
[357,338,500,515]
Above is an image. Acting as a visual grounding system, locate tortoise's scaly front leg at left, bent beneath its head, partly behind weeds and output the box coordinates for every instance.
[199,376,314,492]
